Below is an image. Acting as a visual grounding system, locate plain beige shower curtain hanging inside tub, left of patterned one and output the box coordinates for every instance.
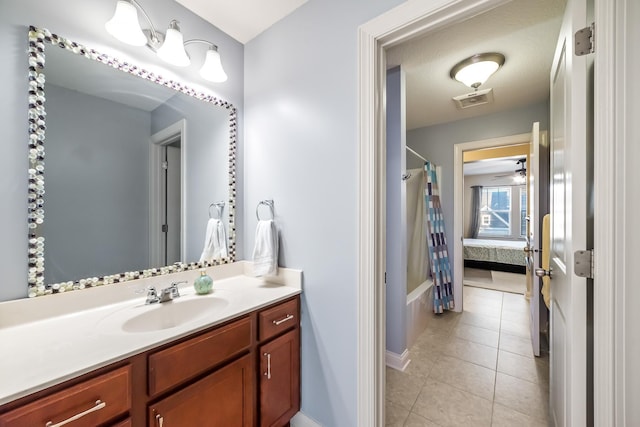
[406,168,429,295]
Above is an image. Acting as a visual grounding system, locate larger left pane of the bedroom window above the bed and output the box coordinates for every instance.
[478,187,511,237]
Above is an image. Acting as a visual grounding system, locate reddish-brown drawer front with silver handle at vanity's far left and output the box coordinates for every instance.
[0,366,131,427]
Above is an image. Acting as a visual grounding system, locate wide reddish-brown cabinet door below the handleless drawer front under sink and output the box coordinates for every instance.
[148,354,255,427]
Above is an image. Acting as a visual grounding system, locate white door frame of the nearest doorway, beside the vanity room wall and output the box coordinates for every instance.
[356,0,620,426]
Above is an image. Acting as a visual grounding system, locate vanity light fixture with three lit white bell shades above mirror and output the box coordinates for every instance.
[105,0,227,83]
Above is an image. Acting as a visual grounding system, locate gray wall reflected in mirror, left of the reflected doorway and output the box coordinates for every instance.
[43,84,151,283]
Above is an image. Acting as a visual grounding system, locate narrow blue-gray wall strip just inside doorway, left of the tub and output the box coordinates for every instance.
[386,67,407,355]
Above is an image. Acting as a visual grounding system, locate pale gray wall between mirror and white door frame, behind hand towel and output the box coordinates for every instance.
[245,0,401,427]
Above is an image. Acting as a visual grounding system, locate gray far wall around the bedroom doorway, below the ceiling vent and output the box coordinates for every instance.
[407,101,549,280]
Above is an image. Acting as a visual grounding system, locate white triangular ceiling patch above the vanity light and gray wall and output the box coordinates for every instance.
[176,0,307,44]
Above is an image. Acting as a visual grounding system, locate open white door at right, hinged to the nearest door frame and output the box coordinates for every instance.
[550,0,588,427]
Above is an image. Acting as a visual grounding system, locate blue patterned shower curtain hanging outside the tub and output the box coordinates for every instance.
[424,162,454,313]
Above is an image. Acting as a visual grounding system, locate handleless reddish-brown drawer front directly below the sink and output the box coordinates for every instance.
[149,317,251,396]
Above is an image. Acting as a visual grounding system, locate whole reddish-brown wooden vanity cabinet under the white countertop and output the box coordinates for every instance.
[0,296,300,427]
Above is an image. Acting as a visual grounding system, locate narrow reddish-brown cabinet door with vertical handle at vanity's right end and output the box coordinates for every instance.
[260,328,300,427]
